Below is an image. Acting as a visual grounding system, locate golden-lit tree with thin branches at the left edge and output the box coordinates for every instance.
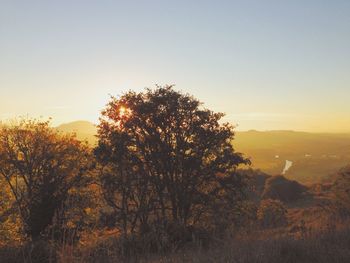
[0,119,89,239]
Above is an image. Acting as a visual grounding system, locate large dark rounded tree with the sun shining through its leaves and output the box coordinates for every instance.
[95,86,249,237]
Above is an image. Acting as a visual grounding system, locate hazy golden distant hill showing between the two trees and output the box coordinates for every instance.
[56,121,97,145]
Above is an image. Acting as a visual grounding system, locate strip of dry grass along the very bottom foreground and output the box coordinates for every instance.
[0,225,350,263]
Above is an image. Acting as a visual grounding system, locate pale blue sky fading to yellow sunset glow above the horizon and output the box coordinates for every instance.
[0,0,350,132]
